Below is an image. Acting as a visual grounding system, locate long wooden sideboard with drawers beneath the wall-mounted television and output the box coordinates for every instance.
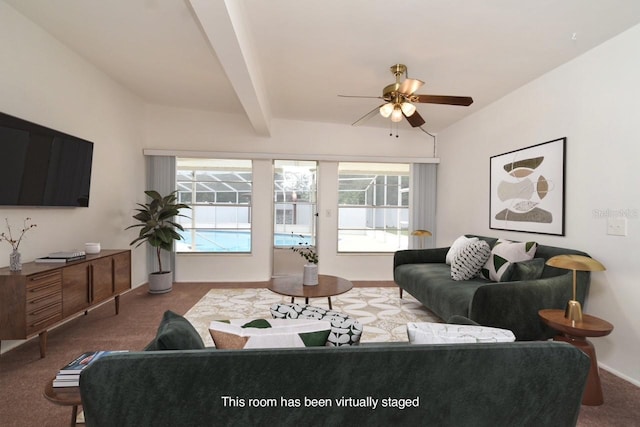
[0,249,131,357]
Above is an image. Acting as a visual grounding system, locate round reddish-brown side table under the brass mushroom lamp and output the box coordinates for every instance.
[538,310,613,406]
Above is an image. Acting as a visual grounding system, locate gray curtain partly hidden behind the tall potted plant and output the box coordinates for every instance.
[145,156,176,280]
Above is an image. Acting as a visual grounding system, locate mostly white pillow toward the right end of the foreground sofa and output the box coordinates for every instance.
[407,322,516,344]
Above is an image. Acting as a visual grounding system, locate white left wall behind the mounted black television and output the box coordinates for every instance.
[0,1,146,349]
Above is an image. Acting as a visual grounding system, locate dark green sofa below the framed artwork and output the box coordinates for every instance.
[393,235,590,340]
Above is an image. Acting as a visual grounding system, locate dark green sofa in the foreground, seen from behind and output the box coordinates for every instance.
[80,341,589,427]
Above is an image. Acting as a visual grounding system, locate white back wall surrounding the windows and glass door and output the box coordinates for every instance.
[145,105,433,282]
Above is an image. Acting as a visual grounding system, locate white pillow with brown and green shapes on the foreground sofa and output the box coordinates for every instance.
[209,319,331,349]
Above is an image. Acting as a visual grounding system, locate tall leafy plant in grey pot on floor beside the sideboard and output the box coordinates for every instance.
[126,190,191,294]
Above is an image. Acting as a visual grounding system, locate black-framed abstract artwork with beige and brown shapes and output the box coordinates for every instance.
[489,138,567,236]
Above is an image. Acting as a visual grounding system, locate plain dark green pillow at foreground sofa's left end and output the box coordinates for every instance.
[145,310,204,350]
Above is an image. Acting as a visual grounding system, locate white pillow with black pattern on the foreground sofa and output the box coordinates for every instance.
[271,303,362,347]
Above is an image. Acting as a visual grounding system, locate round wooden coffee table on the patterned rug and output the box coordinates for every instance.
[268,274,353,310]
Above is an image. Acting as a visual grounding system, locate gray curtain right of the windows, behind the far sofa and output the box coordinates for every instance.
[409,163,437,249]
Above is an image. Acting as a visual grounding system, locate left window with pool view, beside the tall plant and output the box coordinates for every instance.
[176,158,253,252]
